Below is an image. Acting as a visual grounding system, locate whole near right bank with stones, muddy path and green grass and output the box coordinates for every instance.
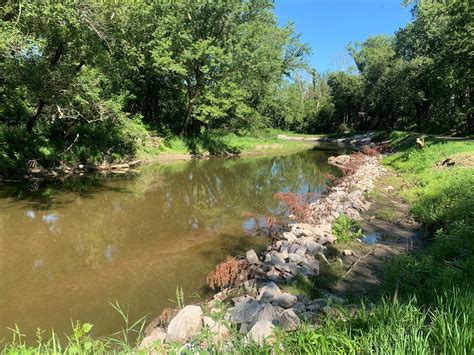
[1,135,474,353]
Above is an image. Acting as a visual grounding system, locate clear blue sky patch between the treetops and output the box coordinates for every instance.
[275,0,411,71]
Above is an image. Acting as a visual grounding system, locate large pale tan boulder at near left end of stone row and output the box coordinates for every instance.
[165,306,202,343]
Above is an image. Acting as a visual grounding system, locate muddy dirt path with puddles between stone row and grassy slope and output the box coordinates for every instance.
[329,175,423,299]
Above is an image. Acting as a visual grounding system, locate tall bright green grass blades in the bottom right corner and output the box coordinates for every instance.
[275,290,474,354]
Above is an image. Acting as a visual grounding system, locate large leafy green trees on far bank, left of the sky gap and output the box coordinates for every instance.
[0,0,308,170]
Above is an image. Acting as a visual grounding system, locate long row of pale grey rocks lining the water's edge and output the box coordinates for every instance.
[142,153,385,348]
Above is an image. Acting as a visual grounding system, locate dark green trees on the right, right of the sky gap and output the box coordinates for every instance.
[280,0,474,134]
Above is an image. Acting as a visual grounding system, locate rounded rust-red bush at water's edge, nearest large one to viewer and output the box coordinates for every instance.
[207,256,249,290]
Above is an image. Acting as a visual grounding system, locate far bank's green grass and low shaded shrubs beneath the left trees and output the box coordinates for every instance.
[0,128,312,177]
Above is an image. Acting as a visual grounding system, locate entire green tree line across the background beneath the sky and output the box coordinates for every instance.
[0,0,474,174]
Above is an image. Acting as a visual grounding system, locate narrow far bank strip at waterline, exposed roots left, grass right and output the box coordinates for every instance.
[0,130,314,181]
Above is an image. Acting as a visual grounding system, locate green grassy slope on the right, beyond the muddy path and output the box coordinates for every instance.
[266,136,474,354]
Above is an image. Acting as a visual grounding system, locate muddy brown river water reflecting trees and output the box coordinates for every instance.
[0,145,341,339]
